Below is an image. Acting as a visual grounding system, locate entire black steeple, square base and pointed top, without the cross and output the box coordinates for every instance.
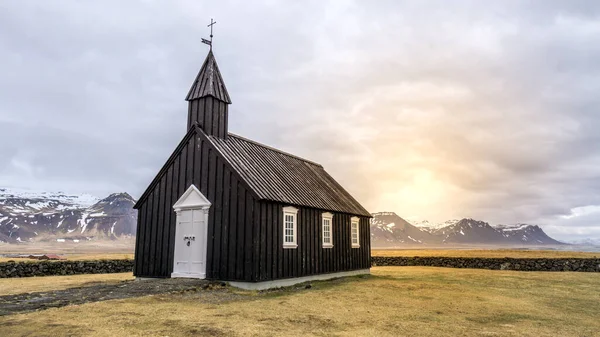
[185,49,231,139]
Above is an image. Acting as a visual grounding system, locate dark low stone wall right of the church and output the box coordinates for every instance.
[371,256,600,272]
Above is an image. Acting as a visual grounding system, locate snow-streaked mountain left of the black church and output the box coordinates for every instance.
[0,188,137,243]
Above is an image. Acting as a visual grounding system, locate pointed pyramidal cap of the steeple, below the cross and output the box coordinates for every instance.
[185,49,231,104]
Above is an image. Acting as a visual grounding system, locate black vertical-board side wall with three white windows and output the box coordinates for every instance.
[254,201,371,281]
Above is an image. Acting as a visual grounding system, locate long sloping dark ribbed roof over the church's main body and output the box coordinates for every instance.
[207,133,371,217]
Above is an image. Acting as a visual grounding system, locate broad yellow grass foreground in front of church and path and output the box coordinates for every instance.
[0,267,600,337]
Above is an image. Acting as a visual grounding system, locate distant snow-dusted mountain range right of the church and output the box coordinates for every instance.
[371,212,561,247]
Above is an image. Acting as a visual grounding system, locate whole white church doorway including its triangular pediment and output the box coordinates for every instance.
[171,184,211,279]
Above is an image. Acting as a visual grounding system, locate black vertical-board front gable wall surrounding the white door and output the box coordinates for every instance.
[134,134,256,281]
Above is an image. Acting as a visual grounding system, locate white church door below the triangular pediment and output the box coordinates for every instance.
[171,208,208,278]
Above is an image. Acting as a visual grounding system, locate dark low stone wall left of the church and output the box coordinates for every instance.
[0,260,133,278]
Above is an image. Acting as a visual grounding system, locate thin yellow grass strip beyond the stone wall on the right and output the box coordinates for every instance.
[371,249,600,258]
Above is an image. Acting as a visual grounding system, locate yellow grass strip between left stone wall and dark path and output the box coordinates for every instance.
[0,273,133,296]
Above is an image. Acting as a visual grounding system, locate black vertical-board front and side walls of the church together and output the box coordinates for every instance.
[134,130,371,281]
